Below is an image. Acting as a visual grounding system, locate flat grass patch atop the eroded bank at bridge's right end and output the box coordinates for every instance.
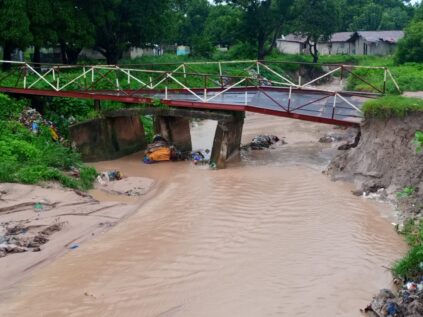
[362,96,423,119]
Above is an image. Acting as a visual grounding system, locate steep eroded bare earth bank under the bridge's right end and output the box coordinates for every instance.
[327,112,423,212]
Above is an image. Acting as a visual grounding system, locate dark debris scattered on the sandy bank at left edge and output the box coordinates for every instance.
[0,222,64,258]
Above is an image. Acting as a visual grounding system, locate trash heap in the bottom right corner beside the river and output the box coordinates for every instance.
[361,278,423,317]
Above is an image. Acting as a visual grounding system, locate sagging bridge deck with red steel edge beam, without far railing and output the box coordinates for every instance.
[0,87,368,126]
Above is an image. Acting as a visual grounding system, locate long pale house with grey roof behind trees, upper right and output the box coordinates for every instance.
[277,31,404,56]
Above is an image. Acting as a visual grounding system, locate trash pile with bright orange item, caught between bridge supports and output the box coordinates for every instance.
[144,134,186,164]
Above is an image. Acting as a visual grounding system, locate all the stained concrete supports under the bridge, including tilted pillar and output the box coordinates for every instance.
[70,108,244,168]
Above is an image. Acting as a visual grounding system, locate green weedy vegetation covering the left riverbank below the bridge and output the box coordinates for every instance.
[0,95,97,190]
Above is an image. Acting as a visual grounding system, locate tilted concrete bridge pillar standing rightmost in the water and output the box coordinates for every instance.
[211,113,244,169]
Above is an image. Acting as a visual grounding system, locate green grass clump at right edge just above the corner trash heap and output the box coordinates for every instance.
[393,221,423,280]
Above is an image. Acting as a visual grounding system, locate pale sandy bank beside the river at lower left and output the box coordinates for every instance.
[0,177,154,297]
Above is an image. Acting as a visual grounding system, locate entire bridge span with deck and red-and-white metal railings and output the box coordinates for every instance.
[0,61,399,125]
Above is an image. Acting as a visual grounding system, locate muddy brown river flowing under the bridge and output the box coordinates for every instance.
[0,115,406,317]
